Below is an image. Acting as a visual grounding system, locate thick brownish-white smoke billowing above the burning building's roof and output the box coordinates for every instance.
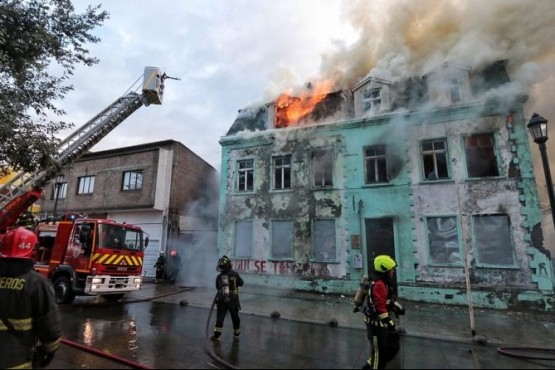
[268,0,555,204]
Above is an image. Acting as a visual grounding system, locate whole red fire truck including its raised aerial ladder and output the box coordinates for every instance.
[0,67,176,304]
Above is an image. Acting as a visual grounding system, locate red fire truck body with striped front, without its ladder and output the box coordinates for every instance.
[34,217,148,304]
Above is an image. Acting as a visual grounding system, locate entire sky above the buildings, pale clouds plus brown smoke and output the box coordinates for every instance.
[61,0,555,180]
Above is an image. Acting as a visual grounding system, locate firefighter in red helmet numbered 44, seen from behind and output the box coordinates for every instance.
[0,227,62,369]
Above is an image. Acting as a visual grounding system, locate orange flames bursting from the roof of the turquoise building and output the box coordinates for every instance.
[275,80,335,128]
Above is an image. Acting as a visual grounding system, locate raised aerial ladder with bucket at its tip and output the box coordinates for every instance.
[0,67,177,234]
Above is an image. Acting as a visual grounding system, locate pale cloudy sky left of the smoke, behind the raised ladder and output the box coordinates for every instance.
[61,0,355,171]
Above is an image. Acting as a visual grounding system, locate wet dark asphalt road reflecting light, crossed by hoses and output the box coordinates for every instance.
[50,298,555,369]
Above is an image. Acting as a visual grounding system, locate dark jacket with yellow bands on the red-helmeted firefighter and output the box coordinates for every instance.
[0,258,62,369]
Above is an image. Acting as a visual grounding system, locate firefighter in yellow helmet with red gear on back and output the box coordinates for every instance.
[354,255,399,369]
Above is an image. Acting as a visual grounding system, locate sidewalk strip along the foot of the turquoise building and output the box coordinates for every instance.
[134,283,555,349]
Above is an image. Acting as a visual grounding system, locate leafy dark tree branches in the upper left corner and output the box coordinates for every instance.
[0,0,108,176]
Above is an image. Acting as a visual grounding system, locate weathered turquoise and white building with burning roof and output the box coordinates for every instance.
[218,62,555,311]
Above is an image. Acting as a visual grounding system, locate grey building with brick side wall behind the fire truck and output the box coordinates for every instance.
[37,140,217,277]
